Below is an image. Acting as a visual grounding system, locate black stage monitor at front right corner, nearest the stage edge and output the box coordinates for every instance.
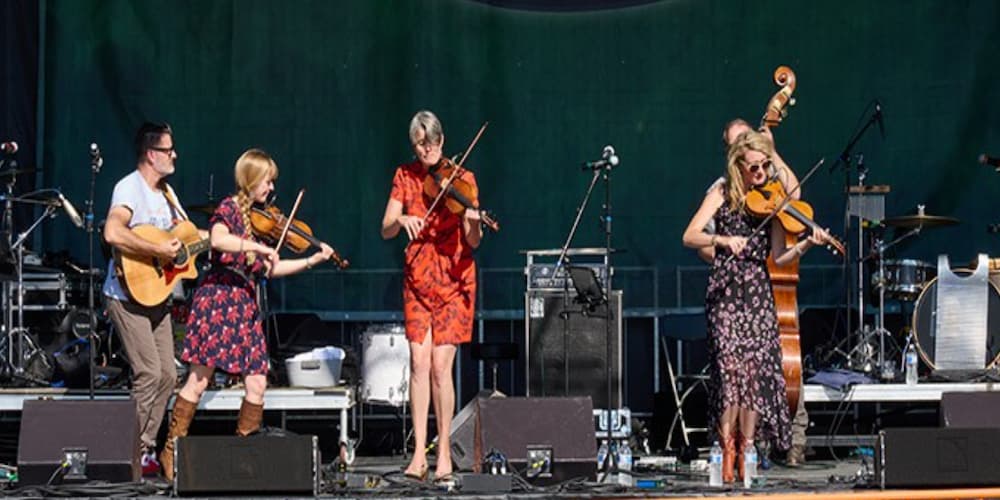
[875,428,1000,488]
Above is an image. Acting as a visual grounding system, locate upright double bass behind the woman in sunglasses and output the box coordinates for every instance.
[761,66,802,417]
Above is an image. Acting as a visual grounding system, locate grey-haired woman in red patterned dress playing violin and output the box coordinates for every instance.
[382,111,483,480]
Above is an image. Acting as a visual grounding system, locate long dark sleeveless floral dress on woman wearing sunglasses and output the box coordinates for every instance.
[705,201,791,449]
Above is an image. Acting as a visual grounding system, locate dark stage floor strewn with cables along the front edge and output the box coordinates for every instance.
[0,456,1000,500]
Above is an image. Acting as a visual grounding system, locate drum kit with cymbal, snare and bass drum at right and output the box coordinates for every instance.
[838,195,1000,380]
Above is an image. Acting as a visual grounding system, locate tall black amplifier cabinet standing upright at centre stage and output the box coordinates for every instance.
[524,290,622,408]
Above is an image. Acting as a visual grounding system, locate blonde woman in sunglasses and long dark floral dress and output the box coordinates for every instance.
[684,131,829,482]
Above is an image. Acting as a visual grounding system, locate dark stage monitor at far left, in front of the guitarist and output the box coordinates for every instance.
[17,400,142,485]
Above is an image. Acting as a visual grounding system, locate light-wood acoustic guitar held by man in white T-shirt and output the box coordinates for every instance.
[114,221,211,306]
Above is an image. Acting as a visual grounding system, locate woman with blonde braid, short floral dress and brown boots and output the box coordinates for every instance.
[160,149,333,480]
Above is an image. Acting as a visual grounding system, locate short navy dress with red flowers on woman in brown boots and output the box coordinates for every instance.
[181,197,268,375]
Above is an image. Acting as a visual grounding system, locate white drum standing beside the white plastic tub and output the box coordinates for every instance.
[361,324,410,406]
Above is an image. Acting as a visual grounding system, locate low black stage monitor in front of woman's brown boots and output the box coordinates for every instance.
[174,435,320,496]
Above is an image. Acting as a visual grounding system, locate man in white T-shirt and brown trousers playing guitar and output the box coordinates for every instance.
[104,122,193,475]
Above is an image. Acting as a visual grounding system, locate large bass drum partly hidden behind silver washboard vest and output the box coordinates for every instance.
[913,269,1000,369]
